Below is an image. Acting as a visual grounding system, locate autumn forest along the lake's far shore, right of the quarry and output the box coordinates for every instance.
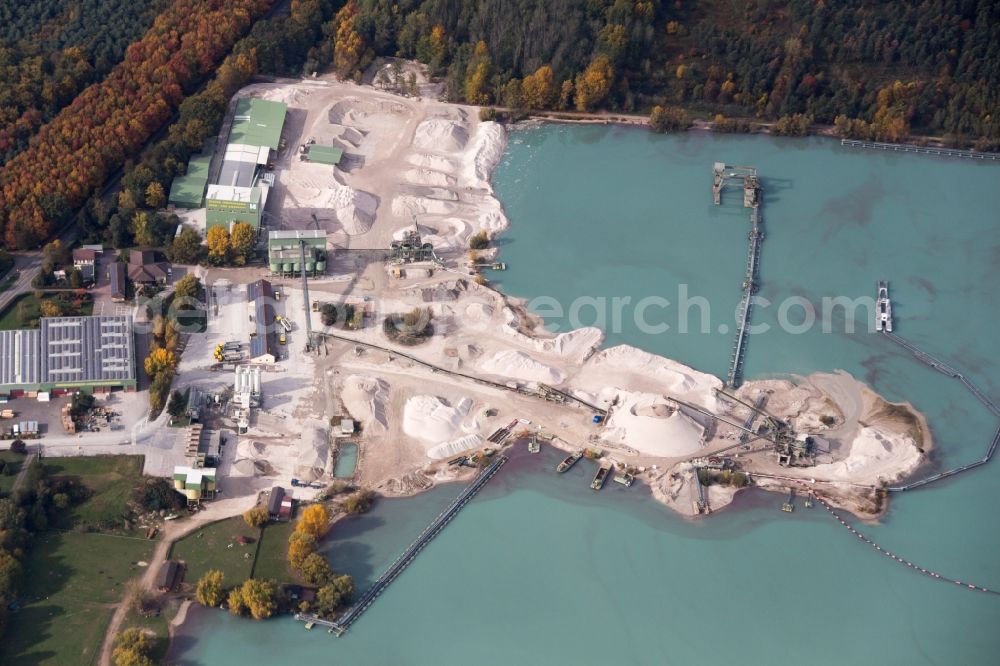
[329,0,1000,148]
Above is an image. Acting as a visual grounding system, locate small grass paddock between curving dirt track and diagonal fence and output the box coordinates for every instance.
[170,516,260,587]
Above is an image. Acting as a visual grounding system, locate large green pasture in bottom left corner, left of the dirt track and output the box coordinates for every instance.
[0,531,154,666]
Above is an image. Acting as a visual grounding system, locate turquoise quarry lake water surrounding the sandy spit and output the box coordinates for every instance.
[170,126,1000,666]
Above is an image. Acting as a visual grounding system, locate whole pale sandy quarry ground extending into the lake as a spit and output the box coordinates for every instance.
[172,66,930,514]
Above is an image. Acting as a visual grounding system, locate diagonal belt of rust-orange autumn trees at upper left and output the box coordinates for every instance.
[0,0,275,248]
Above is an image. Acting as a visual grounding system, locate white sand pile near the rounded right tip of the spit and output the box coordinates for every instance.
[809,427,921,485]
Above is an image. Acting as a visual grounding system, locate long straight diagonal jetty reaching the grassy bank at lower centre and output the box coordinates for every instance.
[295,456,507,636]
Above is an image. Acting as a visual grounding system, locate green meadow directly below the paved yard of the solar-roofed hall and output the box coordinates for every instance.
[44,456,143,530]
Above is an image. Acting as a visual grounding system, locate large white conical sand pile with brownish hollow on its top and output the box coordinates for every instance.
[601,391,705,458]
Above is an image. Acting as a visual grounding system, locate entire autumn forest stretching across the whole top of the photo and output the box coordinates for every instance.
[0,0,1000,249]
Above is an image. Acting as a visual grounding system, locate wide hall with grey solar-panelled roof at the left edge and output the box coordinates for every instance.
[0,315,136,395]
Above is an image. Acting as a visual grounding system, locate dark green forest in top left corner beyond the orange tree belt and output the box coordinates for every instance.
[0,0,167,165]
